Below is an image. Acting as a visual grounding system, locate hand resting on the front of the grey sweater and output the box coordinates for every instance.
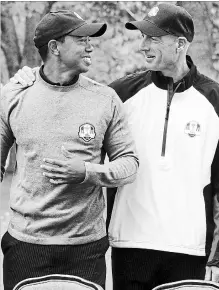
[40,152,86,184]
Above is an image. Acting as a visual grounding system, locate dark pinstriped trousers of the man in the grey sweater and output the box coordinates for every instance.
[1,232,109,290]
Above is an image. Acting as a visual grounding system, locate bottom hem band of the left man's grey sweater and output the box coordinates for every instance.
[8,228,106,245]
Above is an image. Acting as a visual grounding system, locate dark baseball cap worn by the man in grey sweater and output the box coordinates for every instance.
[33,10,107,48]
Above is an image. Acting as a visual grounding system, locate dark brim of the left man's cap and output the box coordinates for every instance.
[71,23,107,37]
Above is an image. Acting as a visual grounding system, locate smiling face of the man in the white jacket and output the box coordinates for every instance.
[140,34,179,72]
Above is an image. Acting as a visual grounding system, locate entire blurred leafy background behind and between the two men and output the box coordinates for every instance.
[0,1,219,290]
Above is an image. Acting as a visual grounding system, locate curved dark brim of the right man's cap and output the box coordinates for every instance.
[125,20,169,36]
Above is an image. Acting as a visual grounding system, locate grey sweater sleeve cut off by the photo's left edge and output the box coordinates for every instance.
[0,89,15,181]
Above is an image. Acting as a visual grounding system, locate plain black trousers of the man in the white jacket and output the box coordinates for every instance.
[112,248,207,290]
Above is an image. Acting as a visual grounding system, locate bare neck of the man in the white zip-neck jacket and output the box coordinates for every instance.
[162,58,190,83]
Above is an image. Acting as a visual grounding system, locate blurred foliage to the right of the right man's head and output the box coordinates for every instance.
[180,1,219,81]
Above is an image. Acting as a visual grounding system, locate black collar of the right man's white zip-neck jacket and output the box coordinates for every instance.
[152,55,197,93]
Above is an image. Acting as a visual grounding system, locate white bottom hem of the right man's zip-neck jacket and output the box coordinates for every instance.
[109,240,206,256]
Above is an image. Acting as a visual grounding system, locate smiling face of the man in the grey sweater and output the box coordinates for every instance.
[58,34,93,75]
